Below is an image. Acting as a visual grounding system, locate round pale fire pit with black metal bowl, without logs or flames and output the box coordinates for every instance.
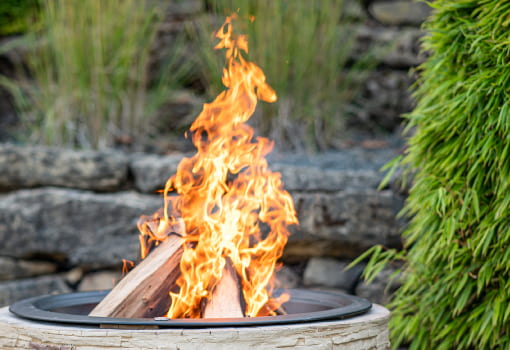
[0,289,389,350]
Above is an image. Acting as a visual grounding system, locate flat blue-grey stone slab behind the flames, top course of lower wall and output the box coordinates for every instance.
[130,148,396,192]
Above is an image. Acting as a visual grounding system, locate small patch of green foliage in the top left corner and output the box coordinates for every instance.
[0,0,39,35]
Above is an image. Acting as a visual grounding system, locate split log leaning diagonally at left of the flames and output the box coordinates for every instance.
[89,234,183,318]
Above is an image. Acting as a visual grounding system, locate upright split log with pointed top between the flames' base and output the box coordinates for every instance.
[202,258,245,318]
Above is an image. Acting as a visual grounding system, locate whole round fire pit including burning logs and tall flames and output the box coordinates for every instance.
[0,17,389,350]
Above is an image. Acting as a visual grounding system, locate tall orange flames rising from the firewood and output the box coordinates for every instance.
[139,17,298,318]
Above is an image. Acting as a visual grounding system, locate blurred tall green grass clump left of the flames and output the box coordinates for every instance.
[8,0,188,148]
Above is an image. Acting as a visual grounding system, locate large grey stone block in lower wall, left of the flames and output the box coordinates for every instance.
[0,188,162,268]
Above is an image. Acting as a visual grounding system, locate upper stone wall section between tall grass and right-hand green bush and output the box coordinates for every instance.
[344,0,430,133]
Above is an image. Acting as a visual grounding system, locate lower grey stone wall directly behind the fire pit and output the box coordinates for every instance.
[0,144,403,305]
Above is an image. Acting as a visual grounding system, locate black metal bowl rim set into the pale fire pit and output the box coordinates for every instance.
[9,289,372,328]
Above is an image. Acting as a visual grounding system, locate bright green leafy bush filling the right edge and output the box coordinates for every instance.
[362,0,510,350]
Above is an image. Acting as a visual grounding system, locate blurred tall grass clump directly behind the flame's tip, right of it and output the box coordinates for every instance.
[189,0,366,149]
